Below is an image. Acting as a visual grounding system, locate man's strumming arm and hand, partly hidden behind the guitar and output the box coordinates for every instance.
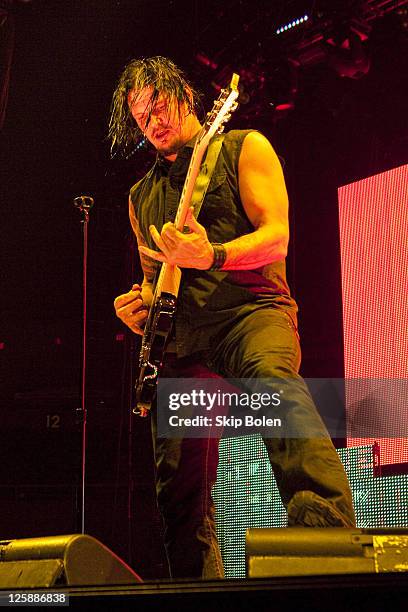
[114,199,156,335]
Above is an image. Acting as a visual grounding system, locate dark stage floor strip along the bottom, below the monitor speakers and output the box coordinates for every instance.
[1,572,408,612]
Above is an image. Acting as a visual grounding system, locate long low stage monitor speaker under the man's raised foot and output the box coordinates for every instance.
[246,527,408,578]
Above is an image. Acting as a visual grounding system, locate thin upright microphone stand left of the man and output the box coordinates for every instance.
[74,195,94,533]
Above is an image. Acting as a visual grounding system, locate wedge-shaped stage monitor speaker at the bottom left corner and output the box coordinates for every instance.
[0,534,142,589]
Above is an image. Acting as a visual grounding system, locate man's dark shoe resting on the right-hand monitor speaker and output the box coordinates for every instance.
[288,491,354,527]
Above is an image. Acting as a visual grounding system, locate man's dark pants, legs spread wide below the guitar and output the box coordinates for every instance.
[152,309,355,578]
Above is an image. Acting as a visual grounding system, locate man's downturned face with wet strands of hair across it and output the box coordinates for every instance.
[128,87,200,160]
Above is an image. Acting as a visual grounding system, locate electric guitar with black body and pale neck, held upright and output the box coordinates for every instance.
[133,74,239,417]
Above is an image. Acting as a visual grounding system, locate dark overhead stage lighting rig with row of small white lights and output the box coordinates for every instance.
[194,0,408,120]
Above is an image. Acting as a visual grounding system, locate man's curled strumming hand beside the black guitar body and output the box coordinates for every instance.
[113,285,152,336]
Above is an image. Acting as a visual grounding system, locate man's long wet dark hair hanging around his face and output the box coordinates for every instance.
[108,55,200,156]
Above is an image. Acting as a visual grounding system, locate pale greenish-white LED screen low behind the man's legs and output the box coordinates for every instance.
[213,435,408,578]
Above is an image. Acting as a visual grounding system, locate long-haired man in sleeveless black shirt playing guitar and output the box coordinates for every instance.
[110,57,354,578]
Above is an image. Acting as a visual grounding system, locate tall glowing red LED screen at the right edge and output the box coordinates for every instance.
[338,165,408,464]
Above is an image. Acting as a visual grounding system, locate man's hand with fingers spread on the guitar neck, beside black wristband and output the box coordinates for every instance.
[139,208,214,270]
